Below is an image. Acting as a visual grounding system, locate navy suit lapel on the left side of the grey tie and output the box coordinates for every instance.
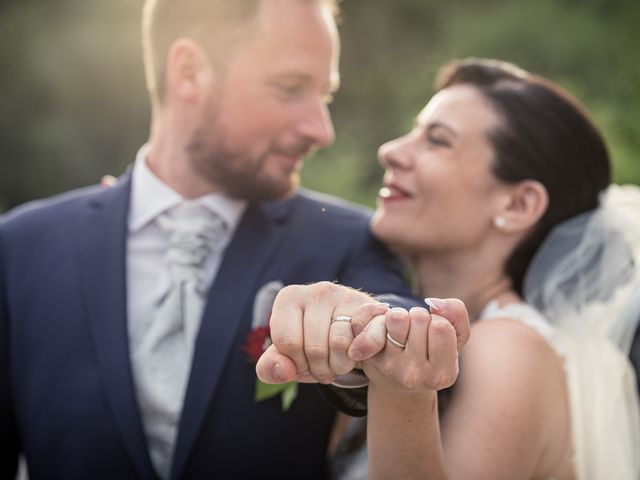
[78,175,155,479]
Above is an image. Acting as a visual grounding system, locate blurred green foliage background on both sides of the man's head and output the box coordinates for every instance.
[0,0,640,211]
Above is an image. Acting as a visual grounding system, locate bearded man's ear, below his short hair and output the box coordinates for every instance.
[166,38,215,105]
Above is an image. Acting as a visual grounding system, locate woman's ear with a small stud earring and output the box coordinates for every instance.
[494,180,549,232]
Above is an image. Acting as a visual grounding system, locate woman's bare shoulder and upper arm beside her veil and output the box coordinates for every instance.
[444,304,570,476]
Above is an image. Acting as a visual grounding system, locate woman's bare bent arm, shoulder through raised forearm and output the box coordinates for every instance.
[365,316,569,479]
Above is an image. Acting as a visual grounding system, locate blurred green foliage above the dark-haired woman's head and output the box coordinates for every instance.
[303,0,640,204]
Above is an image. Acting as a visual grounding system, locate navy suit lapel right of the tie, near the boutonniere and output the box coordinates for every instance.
[171,201,291,478]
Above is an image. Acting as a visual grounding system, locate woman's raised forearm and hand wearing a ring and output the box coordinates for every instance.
[363,309,458,479]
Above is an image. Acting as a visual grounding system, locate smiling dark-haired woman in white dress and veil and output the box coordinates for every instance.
[352,59,640,480]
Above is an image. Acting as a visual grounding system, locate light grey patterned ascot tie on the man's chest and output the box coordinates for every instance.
[132,202,227,479]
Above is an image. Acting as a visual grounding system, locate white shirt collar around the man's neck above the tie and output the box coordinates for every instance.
[129,144,247,233]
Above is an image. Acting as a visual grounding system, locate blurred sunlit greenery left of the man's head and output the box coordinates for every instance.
[0,0,148,207]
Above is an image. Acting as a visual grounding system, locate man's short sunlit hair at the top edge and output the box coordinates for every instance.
[142,0,339,103]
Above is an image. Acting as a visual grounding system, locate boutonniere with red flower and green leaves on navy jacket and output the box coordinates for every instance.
[242,281,298,411]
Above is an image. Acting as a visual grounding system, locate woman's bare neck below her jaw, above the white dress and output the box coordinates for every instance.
[411,248,521,321]
